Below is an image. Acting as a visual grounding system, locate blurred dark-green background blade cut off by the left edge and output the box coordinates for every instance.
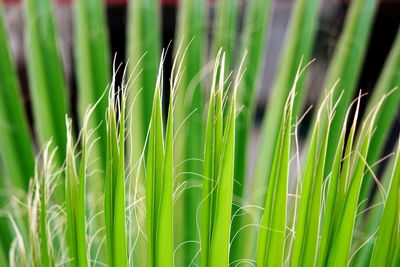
[0,5,34,190]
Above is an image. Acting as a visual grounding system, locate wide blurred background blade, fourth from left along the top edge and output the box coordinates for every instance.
[126,0,161,163]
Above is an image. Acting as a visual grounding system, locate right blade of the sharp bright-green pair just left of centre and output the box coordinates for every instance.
[155,91,174,267]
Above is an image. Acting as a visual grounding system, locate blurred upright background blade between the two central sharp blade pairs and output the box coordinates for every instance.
[174,0,206,266]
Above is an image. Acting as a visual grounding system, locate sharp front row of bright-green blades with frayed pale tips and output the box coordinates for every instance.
[3,52,400,266]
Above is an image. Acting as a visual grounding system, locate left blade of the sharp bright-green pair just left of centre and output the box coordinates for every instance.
[146,84,165,266]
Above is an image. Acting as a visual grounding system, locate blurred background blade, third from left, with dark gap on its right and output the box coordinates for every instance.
[74,0,111,174]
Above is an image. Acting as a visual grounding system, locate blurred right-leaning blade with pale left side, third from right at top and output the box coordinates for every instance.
[250,0,318,209]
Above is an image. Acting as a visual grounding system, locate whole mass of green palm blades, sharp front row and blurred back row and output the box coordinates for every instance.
[0,0,400,267]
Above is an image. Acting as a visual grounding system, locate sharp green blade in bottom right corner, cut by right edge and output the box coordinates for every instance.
[370,140,400,266]
